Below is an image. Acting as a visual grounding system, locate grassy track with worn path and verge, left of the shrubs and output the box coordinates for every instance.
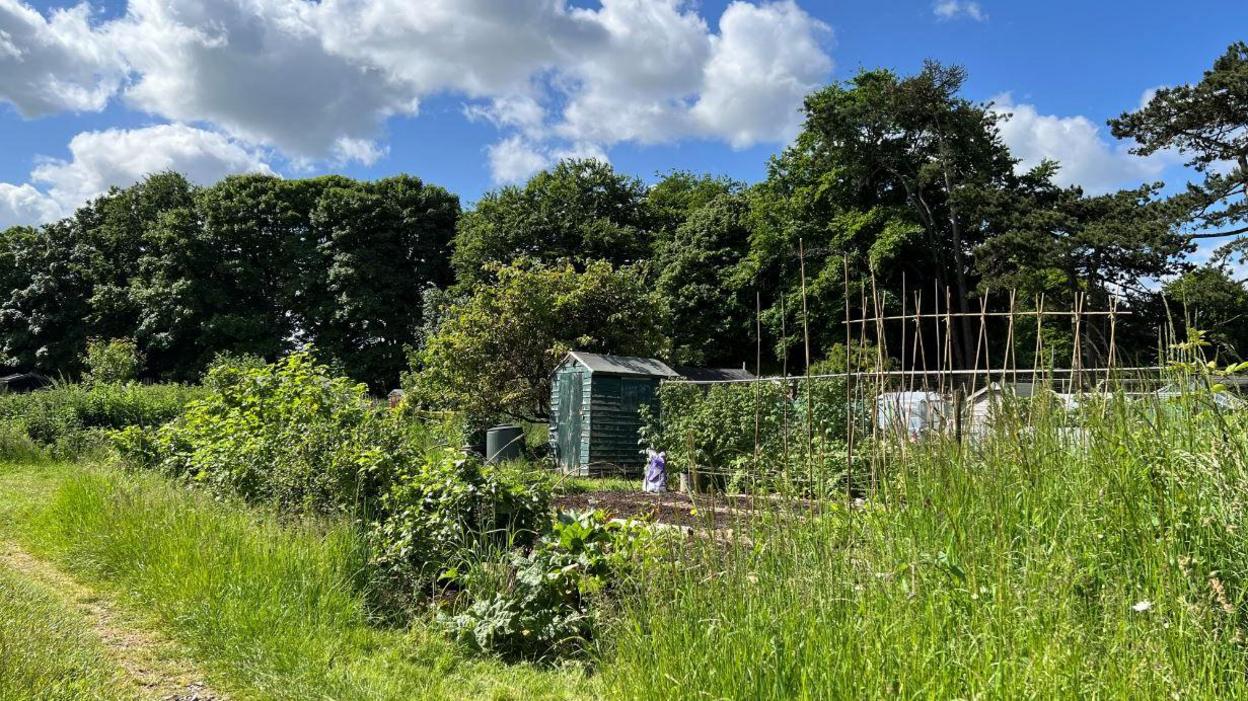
[0,463,598,701]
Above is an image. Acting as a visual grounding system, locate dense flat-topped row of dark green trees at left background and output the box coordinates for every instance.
[0,173,459,392]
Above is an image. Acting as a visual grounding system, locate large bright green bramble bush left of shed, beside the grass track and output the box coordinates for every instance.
[115,351,549,607]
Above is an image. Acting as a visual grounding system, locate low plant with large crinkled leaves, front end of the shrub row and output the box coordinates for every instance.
[443,511,650,660]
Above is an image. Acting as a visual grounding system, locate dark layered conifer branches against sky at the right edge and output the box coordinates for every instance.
[1109,41,1248,256]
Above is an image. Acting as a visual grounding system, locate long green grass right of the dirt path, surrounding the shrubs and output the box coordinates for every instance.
[0,381,1248,699]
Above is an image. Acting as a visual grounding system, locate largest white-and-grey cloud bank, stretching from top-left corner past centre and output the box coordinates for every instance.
[0,0,831,175]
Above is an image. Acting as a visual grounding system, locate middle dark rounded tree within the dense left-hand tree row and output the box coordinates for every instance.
[130,175,316,380]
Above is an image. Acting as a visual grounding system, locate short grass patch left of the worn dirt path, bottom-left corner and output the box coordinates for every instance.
[0,564,134,701]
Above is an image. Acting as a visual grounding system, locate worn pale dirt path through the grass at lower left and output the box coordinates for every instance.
[0,541,227,701]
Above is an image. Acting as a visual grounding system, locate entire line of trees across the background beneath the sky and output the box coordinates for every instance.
[0,49,1248,396]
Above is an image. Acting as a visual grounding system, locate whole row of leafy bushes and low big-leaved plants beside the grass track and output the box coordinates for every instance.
[115,352,631,659]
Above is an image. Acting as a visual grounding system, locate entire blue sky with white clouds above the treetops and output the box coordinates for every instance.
[0,0,1248,245]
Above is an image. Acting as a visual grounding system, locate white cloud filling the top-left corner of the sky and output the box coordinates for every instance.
[0,0,125,117]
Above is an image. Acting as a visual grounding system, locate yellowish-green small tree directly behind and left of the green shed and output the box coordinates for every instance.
[406,261,664,420]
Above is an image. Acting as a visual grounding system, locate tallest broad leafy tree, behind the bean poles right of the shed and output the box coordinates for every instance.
[753,62,1016,363]
